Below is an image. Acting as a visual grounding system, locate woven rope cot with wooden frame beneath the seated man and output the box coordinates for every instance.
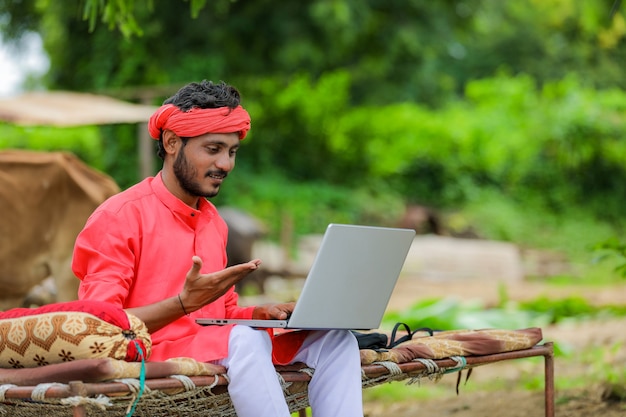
[0,343,554,417]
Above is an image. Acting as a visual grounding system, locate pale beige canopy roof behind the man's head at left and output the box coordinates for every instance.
[0,91,157,126]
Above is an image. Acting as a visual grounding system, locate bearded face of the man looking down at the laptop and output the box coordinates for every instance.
[174,133,239,198]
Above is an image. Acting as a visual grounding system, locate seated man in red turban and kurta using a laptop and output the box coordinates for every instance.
[72,81,363,417]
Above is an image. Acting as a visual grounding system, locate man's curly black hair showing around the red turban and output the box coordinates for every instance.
[157,80,241,159]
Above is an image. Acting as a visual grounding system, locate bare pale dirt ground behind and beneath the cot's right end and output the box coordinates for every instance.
[365,277,626,417]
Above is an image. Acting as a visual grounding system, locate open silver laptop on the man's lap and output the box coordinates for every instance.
[196,224,415,330]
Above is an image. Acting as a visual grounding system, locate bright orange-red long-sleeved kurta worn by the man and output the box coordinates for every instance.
[72,174,253,361]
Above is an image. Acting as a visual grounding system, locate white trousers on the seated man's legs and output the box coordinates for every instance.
[216,326,363,417]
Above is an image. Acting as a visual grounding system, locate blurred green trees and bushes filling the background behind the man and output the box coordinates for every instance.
[0,0,626,218]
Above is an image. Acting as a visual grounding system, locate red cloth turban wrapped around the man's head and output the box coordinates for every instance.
[148,104,250,140]
